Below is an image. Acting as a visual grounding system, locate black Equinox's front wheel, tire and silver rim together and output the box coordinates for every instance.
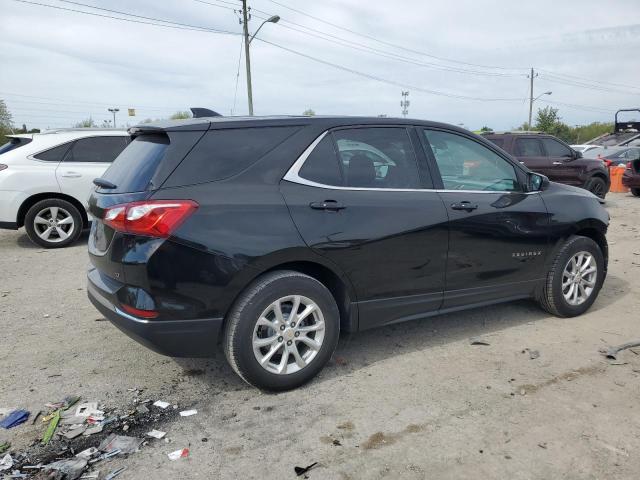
[538,235,605,317]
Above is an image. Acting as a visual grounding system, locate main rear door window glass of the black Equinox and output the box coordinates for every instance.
[333,127,420,189]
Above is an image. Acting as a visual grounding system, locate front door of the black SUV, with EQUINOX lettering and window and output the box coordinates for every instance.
[421,129,549,309]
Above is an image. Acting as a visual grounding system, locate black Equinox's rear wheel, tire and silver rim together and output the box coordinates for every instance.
[223,270,340,391]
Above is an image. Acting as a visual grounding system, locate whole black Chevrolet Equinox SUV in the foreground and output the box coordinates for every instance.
[88,117,609,390]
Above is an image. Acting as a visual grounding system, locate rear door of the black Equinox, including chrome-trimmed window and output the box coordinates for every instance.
[281,127,448,329]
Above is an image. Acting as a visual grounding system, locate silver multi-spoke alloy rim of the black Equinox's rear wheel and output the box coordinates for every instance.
[252,295,325,375]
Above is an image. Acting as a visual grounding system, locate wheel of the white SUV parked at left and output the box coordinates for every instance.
[24,198,83,248]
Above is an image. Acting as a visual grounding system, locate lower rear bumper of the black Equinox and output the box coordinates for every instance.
[87,268,223,357]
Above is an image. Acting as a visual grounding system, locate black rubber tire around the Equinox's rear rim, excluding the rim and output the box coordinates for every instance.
[232,274,340,391]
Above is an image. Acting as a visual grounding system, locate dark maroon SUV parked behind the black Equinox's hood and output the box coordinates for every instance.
[483,132,611,198]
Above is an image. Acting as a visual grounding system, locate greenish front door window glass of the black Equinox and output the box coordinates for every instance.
[424,130,520,192]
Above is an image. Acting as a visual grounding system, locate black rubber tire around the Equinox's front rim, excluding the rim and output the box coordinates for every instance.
[552,237,605,317]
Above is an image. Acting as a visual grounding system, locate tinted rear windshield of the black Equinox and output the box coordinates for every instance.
[97,134,169,193]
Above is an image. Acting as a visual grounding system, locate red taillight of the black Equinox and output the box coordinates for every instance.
[103,200,198,238]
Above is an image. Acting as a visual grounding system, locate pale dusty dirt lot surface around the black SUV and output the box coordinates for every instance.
[0,194,640,480]
